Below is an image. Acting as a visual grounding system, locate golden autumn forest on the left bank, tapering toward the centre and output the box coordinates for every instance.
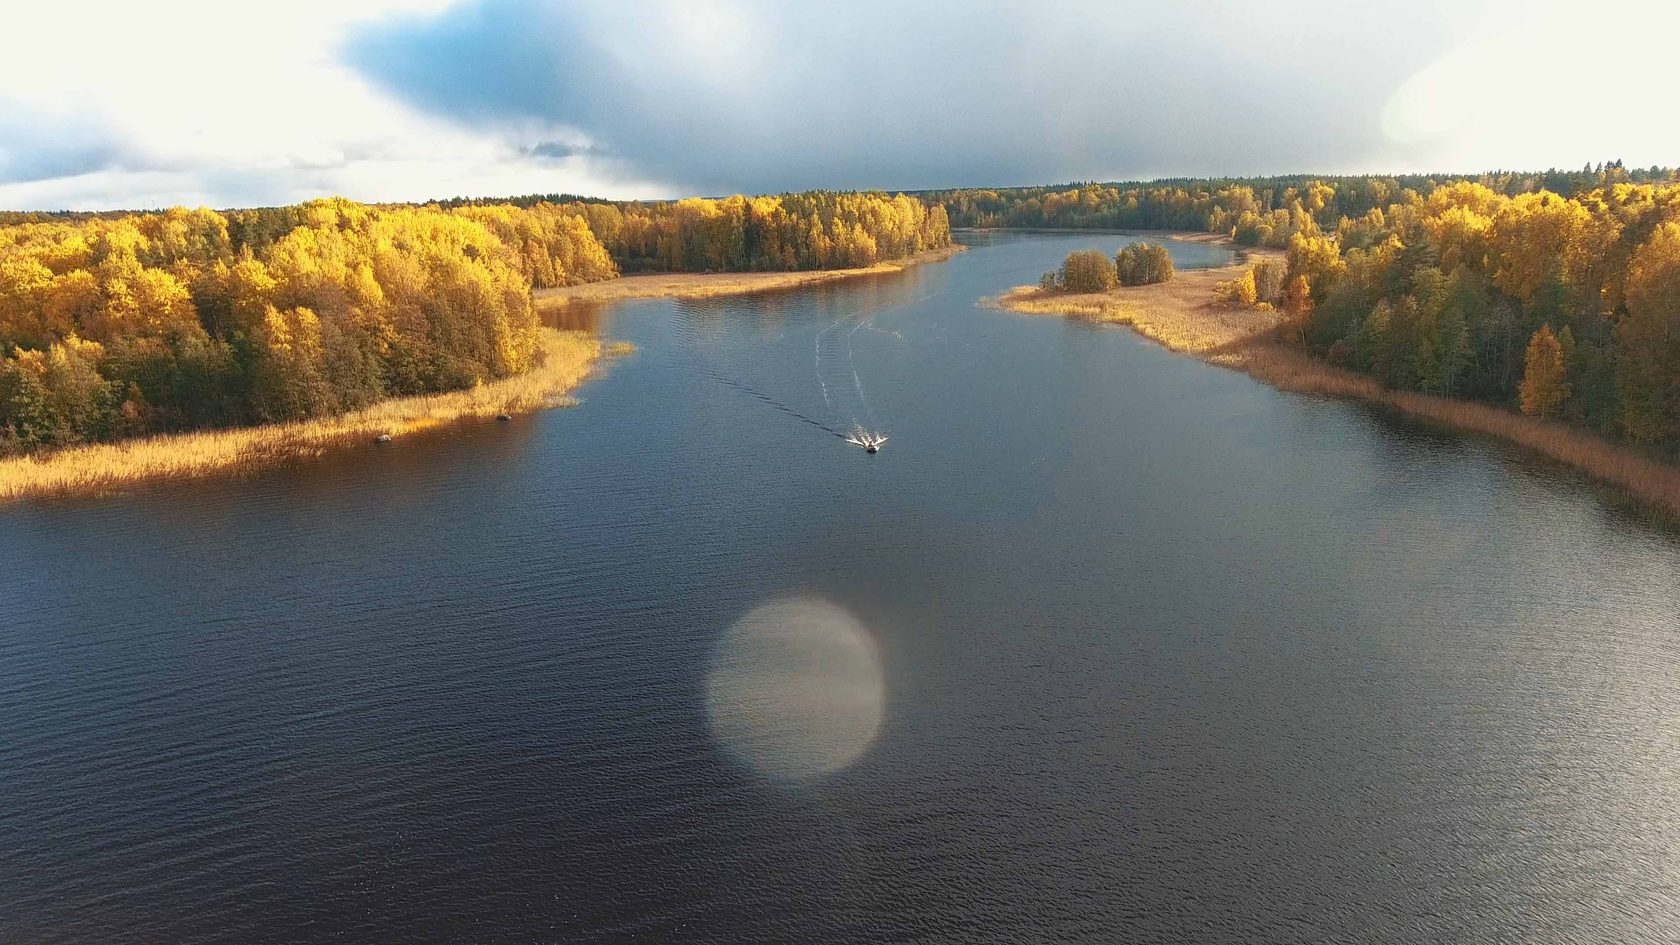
[0,193,951,454]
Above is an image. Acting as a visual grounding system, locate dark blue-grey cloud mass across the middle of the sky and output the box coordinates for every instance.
[344,0,1446,193]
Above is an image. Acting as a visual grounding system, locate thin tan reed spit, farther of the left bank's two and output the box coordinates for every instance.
[531,244,968,308]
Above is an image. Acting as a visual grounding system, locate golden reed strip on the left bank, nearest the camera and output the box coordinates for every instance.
[0,328,620,504]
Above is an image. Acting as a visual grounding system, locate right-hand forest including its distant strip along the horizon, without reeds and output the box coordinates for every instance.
[924,161,1680,457]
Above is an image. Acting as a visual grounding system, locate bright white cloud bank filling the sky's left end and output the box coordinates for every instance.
[0,0,665,209]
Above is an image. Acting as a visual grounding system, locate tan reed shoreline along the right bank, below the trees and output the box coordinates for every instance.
[988,234,1680,521]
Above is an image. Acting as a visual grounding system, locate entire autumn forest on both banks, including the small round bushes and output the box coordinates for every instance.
[0,163,1680,467]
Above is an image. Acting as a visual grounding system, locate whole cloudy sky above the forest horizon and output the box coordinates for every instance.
[0,0,1680,210]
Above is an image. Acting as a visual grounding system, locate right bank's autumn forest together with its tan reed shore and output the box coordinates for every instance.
[981,163,1680,516]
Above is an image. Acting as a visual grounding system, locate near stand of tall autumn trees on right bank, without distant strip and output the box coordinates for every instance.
[1240,180,1680,452]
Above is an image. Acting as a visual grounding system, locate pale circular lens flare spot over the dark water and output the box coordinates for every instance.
[706,597,887,780]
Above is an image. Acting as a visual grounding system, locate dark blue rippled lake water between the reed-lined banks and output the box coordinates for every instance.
[0,234,1680,945]
